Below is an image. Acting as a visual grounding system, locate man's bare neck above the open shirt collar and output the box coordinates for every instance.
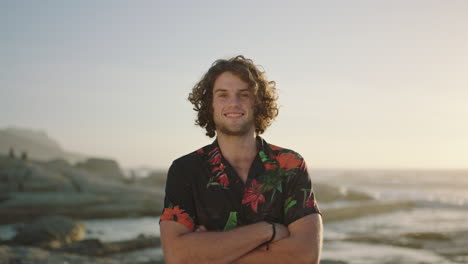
[217,130,258,166]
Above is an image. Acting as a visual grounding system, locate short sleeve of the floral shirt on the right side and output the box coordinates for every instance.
[283,154,322,225]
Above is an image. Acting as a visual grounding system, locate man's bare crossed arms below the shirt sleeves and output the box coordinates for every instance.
[161,214,322,264]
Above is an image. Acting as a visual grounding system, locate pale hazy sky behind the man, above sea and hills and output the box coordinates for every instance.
[0,0,468,169]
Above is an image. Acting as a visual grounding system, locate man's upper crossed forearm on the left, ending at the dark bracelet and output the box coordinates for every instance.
[163,222,271,263]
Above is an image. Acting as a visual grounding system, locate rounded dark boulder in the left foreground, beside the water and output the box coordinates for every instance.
[12,216,85,248]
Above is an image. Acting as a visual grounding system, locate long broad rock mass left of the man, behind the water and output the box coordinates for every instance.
[0,156,164,224]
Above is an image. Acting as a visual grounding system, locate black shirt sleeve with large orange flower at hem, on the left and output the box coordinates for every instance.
[159,159,195,231]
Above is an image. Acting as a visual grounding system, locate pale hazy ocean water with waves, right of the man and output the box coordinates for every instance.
[310,170,468,264]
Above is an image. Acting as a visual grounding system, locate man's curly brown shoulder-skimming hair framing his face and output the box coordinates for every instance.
[188,55,278,138]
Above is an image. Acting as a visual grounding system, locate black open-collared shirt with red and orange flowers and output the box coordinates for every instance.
[160,137,321,231]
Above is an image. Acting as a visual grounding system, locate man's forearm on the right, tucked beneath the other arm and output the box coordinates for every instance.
[233,233,322,264]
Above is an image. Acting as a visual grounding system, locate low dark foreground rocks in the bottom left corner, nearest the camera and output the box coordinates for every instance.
[0,216,165,263]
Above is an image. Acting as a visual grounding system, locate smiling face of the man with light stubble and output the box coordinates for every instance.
[213,72,255,136]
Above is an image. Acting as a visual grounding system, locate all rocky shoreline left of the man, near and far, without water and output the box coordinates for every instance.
[0,155,163,264]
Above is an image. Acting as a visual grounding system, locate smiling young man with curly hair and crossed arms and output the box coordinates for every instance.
[160,56,322,263]
